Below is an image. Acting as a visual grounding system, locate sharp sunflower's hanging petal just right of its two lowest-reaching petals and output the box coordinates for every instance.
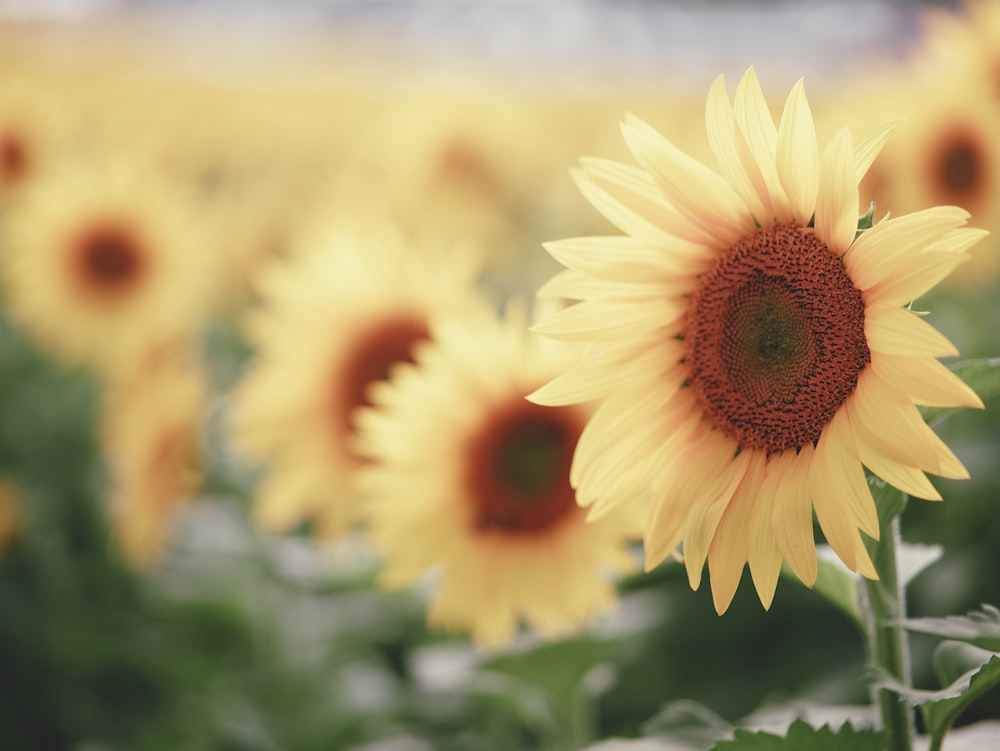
[761,444,817,587]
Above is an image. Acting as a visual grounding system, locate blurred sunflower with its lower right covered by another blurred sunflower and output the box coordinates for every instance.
[231,225,488,538]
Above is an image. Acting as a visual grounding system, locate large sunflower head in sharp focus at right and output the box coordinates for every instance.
[531,69,985,613]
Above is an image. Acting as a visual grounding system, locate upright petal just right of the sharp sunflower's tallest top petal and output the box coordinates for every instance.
[777,78,819,226]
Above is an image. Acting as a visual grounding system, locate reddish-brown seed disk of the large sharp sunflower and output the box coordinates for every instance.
[684,225,871,453]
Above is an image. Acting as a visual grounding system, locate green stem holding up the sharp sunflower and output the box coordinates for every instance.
[861,516,914,751]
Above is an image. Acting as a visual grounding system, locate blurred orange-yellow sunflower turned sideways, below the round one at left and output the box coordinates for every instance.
[101,342,207,567]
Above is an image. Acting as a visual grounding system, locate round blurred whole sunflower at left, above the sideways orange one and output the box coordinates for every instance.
[0,160,210,369]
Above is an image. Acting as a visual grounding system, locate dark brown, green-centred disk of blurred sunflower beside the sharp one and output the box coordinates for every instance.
[466,399,583,533]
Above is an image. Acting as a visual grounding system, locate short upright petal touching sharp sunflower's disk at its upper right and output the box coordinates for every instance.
[815,128,858,256]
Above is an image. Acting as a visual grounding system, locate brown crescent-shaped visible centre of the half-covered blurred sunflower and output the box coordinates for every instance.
[337,315,430,430]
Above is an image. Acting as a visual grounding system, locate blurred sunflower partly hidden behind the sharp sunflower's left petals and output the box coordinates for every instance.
[358,312,642,647]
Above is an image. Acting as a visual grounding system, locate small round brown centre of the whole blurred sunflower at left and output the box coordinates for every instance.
[73,223,146,297]
